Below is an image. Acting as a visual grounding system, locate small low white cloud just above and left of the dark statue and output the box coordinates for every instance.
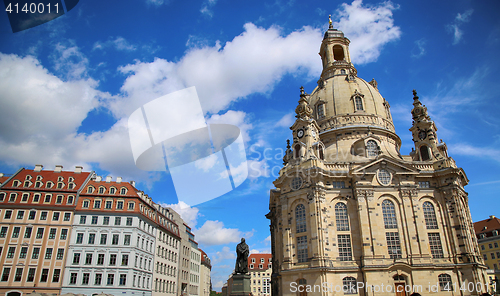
[193,220,242,246]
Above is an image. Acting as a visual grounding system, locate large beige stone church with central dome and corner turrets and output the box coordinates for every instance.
[266,21,487,296]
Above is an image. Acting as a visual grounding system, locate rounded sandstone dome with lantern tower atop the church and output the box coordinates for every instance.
[296,23,401,161]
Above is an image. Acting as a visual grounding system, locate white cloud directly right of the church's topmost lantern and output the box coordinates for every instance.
[334,0,401,64]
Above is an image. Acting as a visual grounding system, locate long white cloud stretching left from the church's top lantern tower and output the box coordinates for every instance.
[110,23,321,117]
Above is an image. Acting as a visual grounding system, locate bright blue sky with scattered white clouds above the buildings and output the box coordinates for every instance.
[0,0,500,289]
